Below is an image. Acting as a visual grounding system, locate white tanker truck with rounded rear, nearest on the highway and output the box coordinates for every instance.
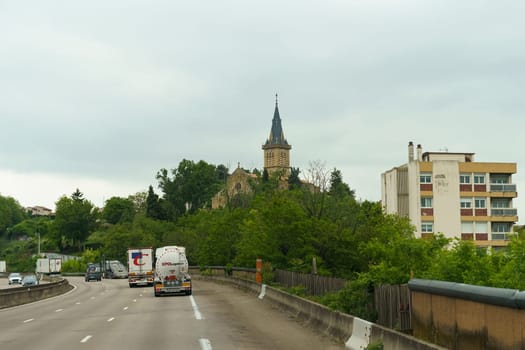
[153,246,191,297]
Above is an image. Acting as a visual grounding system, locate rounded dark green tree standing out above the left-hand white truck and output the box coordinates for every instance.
[53,189,97,249]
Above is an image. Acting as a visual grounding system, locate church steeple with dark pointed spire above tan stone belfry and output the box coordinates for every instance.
[262,94,292,174]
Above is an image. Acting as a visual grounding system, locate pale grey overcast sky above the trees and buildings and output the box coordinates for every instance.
[0,0,525,223]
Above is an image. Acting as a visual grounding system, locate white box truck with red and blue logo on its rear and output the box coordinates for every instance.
[128,247,153,288]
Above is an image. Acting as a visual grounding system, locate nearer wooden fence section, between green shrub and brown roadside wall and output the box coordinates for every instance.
[374,284,412,333]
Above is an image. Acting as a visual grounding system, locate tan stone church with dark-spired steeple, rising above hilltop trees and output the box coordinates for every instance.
[212,95,292,209]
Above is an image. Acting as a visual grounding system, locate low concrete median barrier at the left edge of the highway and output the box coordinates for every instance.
[0,279,73,309]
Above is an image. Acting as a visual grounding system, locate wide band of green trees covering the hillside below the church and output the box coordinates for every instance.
[0,160,525,318]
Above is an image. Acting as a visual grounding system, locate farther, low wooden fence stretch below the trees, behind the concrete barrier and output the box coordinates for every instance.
[274,269,347,296]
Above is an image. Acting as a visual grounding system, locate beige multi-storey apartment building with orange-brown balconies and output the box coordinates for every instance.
[381,142,518,249]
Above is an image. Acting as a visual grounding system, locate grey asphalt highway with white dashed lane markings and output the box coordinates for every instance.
[0,277,344,350]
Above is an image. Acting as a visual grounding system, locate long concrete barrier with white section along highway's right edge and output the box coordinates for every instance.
[192,274,446,350]
